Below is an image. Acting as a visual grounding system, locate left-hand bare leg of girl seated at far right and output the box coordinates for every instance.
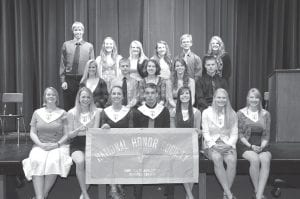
[243,151,260,193]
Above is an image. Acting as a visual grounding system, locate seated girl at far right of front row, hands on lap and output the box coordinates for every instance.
[237,88,272,199]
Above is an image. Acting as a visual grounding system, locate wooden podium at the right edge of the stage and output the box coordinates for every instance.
[269,69,300,142]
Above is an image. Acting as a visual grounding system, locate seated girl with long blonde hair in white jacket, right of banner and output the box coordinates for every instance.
[202,88,238,199]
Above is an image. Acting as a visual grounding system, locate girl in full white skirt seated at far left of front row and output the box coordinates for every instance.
[22,87,72,199]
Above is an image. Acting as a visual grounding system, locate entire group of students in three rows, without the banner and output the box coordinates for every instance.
[23,22,271,199]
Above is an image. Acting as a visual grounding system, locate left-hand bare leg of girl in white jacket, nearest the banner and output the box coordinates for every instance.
[211,151,232,198]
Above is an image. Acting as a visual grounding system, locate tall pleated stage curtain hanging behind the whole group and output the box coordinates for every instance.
[0,0,300,126]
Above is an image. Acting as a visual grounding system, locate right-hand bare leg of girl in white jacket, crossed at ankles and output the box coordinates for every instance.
[224,150,237,189]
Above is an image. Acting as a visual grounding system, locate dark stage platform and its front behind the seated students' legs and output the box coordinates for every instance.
[0,137,300,199]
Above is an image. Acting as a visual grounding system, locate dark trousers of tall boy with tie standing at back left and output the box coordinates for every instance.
[63,75,82,111]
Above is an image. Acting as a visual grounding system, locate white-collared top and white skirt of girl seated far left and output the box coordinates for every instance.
[22,108,72,180]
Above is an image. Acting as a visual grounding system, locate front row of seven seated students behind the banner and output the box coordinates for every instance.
[23,83,271,199]
